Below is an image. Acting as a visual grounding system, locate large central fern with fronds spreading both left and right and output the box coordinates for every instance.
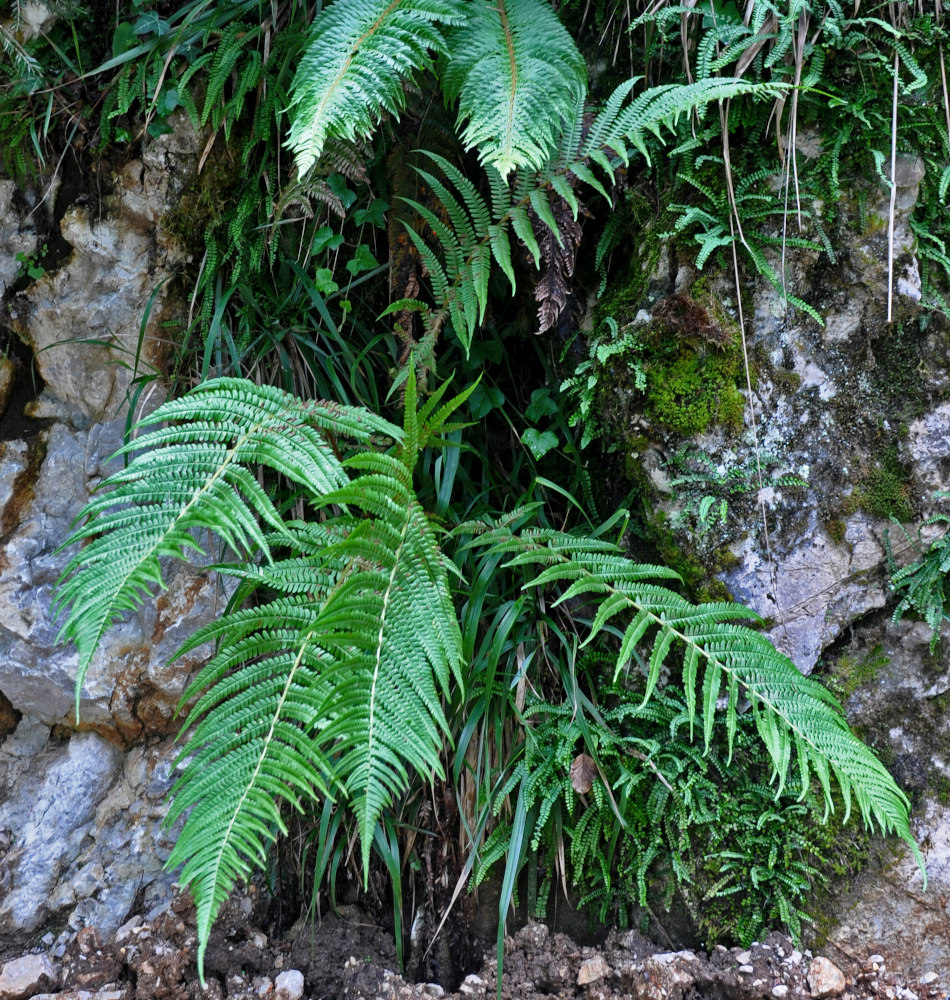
[58,369,916,976]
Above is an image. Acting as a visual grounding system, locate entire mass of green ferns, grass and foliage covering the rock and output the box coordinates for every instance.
[0,0,950,976]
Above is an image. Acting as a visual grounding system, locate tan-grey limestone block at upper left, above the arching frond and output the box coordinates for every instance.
[10,117,199,426]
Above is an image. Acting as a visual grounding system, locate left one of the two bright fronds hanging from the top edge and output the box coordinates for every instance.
[288,0,462,174]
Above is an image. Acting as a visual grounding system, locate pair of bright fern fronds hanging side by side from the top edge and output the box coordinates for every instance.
[289,0,587,175]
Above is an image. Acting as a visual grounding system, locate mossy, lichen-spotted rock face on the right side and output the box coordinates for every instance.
[597,160,950,975]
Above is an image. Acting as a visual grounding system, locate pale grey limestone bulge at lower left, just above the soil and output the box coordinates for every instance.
[0,716,177,940]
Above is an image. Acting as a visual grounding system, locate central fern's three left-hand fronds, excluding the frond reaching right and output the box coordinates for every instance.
[58,379,472,976]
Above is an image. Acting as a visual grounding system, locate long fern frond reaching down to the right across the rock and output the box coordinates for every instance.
[469,527,923,867]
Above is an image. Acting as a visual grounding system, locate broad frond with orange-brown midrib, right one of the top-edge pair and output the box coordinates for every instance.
[442,0,587,177]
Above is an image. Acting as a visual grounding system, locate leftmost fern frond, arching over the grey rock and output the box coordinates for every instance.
[56,379,401,717]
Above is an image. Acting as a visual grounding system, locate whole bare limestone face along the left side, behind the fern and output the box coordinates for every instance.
[0,124,222,952]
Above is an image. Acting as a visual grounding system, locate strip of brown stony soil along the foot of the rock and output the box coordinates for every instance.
[24,886,950,1000]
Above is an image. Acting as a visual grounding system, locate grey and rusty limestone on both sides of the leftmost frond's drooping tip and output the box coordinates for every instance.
[0,420,223,740]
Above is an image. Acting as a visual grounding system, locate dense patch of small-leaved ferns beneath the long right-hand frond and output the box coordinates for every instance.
[475,678,856,946]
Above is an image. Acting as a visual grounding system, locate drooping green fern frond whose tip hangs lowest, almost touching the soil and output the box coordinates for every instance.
[168,616,332,973]
